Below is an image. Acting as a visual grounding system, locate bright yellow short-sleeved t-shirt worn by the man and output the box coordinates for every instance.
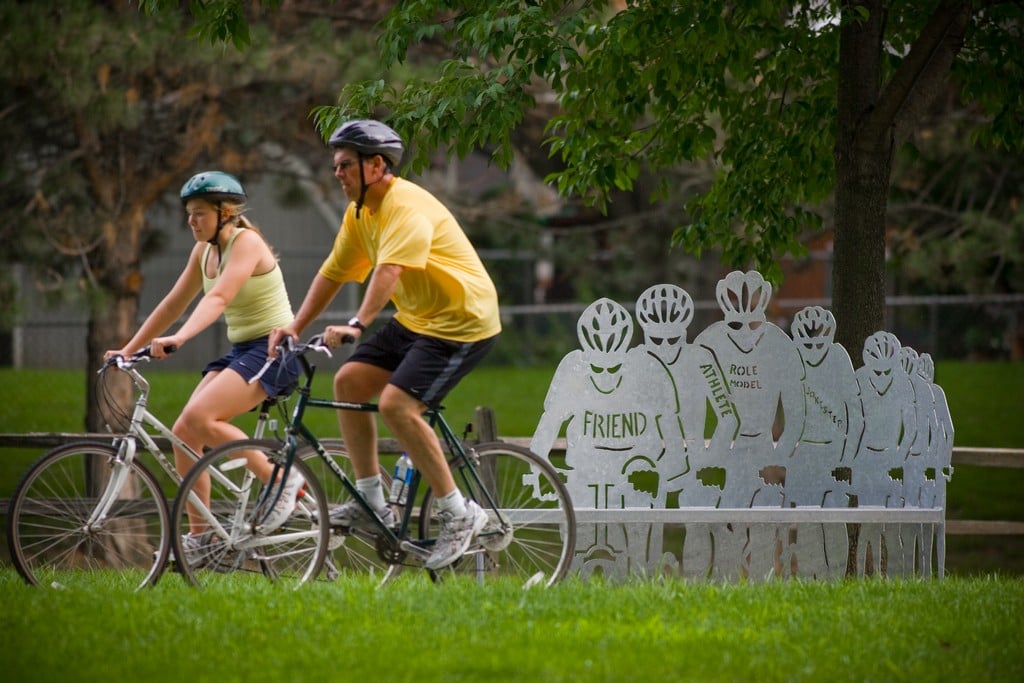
[319,178,502,342]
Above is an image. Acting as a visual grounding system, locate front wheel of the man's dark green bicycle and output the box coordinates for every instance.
[171,439,329,587]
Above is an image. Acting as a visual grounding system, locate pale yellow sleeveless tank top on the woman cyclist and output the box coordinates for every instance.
[203,228,294,344]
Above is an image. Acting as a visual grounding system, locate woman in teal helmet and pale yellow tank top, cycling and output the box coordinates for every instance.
[104,171,304,547]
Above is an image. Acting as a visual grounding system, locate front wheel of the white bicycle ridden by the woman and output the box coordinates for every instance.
[7,442,170,588]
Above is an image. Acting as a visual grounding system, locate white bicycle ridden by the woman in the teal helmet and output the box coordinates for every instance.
[7,348,326,589]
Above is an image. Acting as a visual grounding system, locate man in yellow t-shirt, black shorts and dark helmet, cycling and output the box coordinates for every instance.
[269,120,501,569]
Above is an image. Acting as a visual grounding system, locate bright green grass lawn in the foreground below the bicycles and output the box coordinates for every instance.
[0,569,1024,683]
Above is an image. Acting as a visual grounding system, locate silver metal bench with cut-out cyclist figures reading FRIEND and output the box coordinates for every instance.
[530,271,953,580]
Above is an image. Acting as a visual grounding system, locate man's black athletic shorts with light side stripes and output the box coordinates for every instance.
[345,318,498,408]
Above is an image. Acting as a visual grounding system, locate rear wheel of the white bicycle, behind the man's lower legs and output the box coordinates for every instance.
[297,439,394,581]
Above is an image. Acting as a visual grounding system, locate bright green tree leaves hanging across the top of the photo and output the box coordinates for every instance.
[136,0,1024,290]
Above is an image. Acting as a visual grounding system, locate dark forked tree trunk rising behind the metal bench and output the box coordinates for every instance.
[833,0,974,367]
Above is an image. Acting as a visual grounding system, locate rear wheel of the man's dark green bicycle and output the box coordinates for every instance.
[420,441,575,586]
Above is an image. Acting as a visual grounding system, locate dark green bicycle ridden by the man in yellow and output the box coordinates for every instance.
[190,336,575,587]
